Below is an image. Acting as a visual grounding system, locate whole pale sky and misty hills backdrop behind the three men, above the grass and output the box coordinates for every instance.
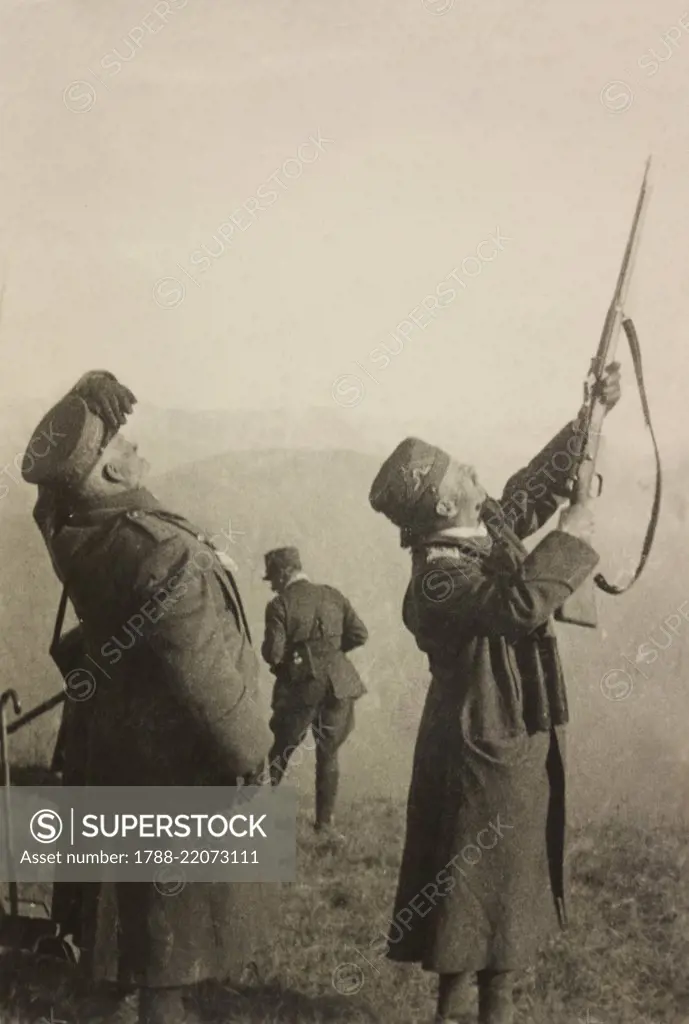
[0,0,689,1020]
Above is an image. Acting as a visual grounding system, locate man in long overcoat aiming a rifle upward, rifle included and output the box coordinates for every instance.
[370,153,659,1024]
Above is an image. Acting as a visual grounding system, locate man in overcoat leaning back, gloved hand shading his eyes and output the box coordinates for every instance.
[23,371,270,1024]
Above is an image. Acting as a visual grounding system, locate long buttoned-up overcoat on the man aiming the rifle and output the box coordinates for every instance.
[388,425,598,974]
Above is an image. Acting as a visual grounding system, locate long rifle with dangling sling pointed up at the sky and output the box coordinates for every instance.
[555,157,661,629]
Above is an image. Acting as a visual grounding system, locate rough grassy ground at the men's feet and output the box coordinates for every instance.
[0,799,689,1024]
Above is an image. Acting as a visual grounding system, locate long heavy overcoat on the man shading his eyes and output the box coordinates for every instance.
[36,489,273,987]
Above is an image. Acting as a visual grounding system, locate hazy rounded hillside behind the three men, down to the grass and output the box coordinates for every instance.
[0,438,689,815]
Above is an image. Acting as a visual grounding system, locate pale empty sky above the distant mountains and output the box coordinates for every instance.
[0,0,689,458]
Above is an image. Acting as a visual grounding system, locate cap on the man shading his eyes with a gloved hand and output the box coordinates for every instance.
[21,392,112,486]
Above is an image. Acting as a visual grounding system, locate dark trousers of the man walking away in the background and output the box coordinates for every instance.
[270,683,354,827]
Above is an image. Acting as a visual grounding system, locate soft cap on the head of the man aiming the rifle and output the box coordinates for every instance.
[369,437,450,529]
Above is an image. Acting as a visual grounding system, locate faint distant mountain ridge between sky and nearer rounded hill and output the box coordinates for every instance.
[0,401,675,519]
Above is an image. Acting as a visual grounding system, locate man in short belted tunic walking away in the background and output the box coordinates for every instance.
[262,548,369,831]
